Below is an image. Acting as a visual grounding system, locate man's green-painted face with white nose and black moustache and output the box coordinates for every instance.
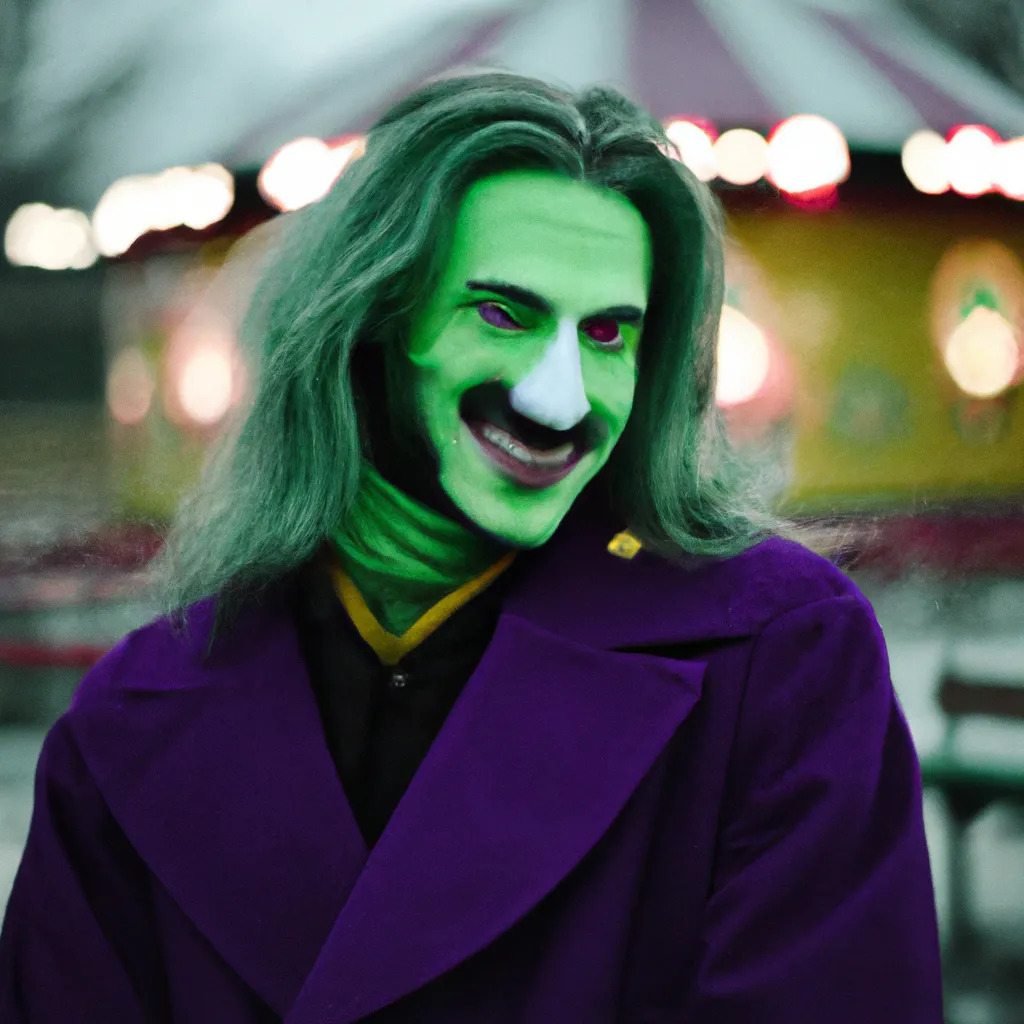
[410,171,651,548]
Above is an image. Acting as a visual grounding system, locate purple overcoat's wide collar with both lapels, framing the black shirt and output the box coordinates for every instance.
[72,507,753,1024]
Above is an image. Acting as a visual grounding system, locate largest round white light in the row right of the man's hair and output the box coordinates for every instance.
[768,114,850,196]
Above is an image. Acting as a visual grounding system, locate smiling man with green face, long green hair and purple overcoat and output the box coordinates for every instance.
[0,75,941,1024]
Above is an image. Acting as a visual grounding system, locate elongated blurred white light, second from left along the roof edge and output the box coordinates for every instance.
[92,164,234,256]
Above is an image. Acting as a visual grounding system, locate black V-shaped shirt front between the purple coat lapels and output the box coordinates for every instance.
[295,551,515,847]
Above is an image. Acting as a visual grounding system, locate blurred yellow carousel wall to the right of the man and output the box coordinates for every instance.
[731,201,1024,510]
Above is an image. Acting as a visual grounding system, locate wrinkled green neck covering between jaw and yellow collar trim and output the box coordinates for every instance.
[331,464,505,636]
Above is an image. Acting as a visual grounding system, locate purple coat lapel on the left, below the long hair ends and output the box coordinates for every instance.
[71,597,367,1017]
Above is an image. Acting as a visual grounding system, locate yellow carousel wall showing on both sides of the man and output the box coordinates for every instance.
[112,200,1024,517]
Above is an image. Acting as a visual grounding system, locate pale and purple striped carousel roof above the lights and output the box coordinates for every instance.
[13,0,1024,206]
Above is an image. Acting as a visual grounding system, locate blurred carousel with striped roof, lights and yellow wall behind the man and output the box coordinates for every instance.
[56,0,1024,519]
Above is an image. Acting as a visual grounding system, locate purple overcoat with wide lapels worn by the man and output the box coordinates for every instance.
[0,516,942,1024]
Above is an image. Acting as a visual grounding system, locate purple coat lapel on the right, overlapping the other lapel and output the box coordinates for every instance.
[287,612,703,1024]
